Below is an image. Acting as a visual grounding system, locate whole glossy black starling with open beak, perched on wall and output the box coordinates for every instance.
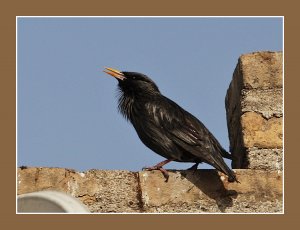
[104,68,238,182]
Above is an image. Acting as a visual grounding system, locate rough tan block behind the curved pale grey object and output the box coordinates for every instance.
[18,168,140,213]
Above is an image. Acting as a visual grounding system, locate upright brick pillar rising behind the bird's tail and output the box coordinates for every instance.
[225,51,283,170]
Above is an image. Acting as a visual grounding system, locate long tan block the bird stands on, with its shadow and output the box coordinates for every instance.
[140,170,282,212]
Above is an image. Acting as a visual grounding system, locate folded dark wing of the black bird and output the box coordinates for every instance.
[158,98,231,163]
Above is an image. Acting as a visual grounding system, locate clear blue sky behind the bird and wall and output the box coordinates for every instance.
[17,17,283,171]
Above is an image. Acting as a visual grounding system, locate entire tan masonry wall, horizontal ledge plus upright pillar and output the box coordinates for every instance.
[17,52,283,213]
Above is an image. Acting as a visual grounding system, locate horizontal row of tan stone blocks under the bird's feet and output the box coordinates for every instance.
[17,167,283,213]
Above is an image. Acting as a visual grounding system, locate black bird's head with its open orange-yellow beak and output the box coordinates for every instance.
[104,68,160,96]
